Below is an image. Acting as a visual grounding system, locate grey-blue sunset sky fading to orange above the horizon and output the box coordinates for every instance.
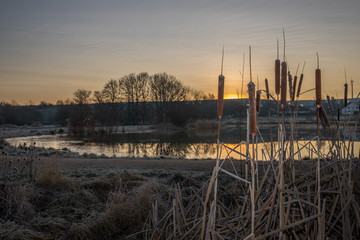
[0,0,360,104]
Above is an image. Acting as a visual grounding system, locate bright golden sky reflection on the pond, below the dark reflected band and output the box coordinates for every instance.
[6,135,360,160]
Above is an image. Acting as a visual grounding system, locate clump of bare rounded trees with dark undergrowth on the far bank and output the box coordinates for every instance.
[56,72,215,135]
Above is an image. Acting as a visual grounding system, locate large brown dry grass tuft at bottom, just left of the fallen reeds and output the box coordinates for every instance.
[69,181,161,239]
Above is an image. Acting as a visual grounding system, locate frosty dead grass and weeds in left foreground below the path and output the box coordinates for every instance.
[0,154,214,239]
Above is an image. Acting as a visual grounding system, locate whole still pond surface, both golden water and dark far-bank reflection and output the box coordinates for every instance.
[7,133,360,160]
